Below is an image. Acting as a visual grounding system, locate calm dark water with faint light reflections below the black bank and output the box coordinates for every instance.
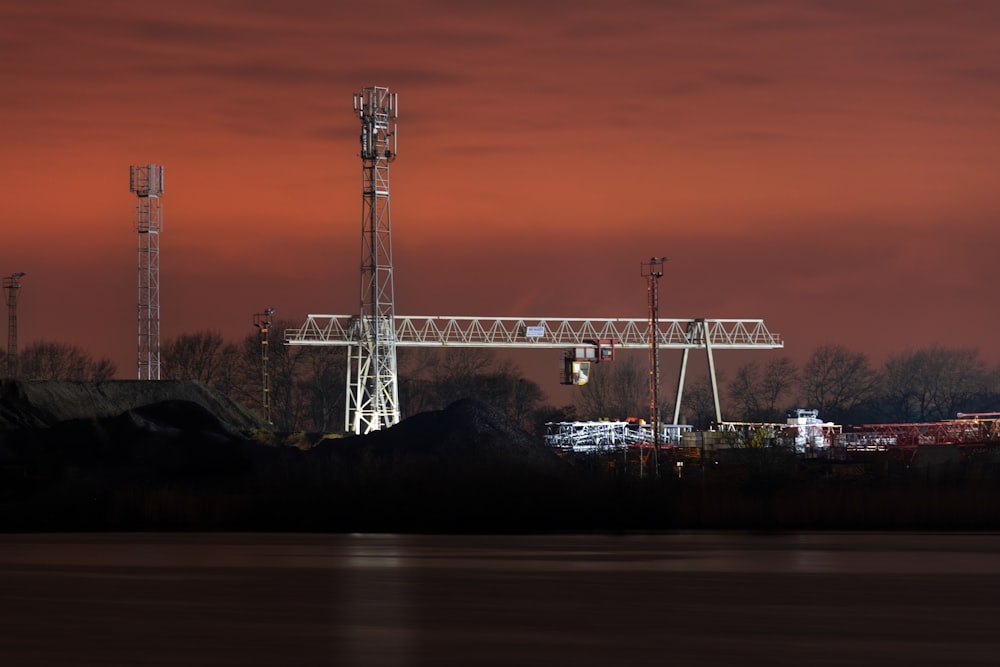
[0,533,1000,667]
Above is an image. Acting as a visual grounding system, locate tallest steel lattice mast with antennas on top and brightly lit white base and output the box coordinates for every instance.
[345,86,399,434]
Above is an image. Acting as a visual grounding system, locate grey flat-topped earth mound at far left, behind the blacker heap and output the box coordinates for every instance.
[0,380,261,432]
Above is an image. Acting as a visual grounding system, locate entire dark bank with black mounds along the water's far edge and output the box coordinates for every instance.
[0,382,1000,533]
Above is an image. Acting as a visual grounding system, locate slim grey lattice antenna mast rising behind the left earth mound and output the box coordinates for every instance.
[129,164,163,380]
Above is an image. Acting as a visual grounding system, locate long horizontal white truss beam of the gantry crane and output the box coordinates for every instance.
[284,315,784,350]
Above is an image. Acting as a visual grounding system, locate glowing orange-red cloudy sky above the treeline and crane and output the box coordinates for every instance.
[0,0,1000,389]
